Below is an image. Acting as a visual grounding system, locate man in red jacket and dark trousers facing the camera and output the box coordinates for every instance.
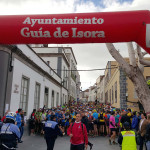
[67,114,88,150]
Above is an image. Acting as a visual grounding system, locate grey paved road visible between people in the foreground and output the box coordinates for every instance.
[18,136,120,150]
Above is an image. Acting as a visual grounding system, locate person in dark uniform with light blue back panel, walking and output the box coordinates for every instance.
[43,115,63,150]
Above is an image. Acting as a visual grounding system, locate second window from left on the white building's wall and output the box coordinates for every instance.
[34,83,40,110]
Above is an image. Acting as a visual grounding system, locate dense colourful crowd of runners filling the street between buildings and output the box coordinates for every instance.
[1,101,150,150]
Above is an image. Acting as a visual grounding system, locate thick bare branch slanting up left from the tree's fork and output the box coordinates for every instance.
[106,43,131,74]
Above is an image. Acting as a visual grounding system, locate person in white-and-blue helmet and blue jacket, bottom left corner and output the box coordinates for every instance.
[0,112,20,150]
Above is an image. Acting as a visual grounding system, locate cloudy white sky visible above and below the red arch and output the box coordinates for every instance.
[0,0,150,89]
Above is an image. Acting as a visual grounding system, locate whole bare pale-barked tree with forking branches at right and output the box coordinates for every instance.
[106,42,150,113]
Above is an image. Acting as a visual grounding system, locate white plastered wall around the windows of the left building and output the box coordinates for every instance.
[10,56,67,117]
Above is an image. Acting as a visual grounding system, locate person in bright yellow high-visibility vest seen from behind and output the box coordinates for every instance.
[118,122,137,150]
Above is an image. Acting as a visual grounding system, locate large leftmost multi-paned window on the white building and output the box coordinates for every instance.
[19,77,29,112]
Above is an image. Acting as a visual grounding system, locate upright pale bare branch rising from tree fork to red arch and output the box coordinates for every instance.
[127,42,136,67]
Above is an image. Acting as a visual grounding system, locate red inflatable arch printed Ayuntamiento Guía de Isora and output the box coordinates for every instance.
[0,10,150,53]
